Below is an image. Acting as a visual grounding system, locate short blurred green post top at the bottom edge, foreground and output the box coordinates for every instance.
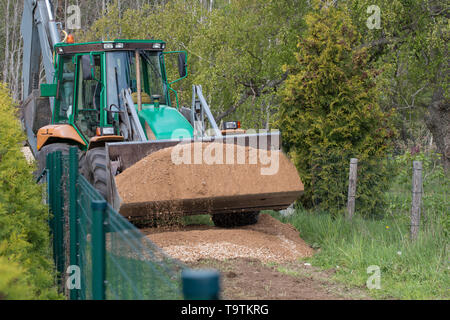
[181,270,220,300]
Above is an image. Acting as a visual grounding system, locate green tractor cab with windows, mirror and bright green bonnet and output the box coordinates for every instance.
[38,40,193,149]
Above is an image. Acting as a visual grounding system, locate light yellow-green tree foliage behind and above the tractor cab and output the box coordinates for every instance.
[82,0,306,128]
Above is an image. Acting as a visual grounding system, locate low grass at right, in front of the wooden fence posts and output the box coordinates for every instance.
[273,211,450,299]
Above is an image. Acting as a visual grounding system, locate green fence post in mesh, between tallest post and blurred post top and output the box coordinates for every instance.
[91,200,106,300]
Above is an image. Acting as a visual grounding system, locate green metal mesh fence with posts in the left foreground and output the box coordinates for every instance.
[47,147,219,300]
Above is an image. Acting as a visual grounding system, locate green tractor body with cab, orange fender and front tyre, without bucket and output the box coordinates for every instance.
[36,40,194,198]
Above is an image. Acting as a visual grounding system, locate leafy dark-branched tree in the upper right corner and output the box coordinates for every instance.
[348,0,450,172]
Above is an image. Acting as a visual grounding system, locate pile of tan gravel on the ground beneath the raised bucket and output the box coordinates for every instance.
[144,214,314,262]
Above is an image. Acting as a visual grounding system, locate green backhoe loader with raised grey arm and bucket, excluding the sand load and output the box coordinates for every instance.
[22,0,303,227]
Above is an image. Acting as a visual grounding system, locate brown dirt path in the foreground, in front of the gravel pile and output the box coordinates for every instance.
[189,259,368,300]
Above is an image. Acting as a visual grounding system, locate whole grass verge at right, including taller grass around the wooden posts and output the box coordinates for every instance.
[271,169,450,299]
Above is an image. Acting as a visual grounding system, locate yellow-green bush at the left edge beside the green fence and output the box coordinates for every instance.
[0,83,58,299]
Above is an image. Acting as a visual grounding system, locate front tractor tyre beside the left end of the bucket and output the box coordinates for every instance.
[82,148,109,199]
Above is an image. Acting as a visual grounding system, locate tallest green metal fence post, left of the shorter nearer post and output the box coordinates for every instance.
[69,147,80,300]
